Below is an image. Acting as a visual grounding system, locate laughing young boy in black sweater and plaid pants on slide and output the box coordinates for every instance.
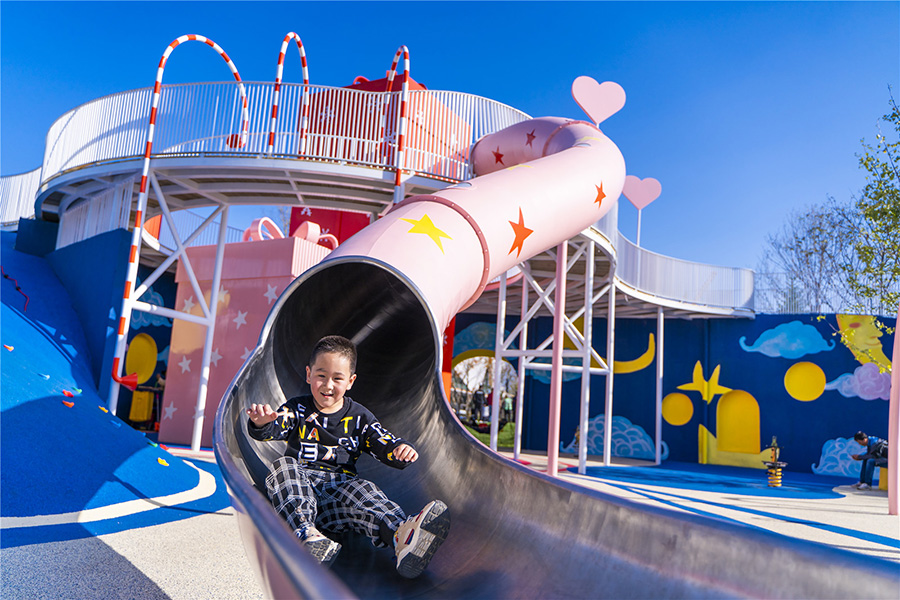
[247,336,450,578]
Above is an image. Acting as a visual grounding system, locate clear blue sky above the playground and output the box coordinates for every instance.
[0,0,900,268]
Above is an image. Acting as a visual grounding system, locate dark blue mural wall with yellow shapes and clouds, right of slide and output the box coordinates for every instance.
[454,314,895,477]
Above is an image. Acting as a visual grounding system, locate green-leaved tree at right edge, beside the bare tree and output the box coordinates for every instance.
[847,95,900,314]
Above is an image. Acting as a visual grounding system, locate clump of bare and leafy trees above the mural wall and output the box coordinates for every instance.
[757,91,900,314]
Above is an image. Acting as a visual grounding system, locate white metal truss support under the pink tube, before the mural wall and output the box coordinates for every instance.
[491,236,615,477]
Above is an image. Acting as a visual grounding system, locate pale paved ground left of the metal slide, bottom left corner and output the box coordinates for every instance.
[0,451,263,600]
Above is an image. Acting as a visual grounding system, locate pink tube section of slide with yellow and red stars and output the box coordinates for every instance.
[327,117,625,331]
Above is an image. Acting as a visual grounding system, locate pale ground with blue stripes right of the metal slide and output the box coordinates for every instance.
[503,452,900,564]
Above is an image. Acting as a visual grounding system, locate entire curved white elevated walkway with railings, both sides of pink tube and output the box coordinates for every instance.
[0,82,754,317]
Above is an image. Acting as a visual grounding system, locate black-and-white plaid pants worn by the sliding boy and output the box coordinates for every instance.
[266,456,406,548]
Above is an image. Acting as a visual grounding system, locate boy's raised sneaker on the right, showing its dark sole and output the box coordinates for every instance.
[394,500,450,579]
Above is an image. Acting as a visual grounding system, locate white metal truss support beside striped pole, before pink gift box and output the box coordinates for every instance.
[108,171,228,450]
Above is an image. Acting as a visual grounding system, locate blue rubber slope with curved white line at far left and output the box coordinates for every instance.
[0,232,230,548]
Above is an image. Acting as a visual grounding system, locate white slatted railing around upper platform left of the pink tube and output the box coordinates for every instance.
[43,82,528,182]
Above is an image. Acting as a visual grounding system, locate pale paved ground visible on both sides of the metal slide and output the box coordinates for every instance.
[0,449,900,600]
